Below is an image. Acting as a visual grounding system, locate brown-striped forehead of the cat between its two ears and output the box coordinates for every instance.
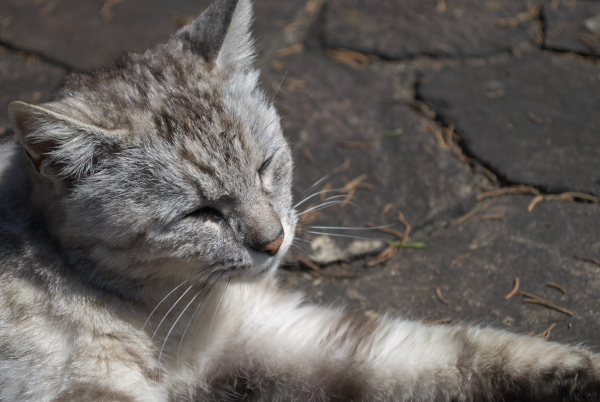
[63,44,278,149]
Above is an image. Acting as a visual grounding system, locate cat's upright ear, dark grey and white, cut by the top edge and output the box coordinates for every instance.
[176,0,255,70]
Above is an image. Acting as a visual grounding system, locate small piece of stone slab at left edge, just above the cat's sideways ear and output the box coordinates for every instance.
[0,48,64,137]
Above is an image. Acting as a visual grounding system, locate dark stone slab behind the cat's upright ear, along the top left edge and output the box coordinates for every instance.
[0,0,300,69]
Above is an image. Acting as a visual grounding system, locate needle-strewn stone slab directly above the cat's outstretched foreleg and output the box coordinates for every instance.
[284,195,600,347]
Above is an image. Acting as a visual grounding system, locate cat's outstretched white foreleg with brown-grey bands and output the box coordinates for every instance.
[204,283,600,401]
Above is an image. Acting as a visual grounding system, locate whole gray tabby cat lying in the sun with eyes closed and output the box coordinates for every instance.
[0,0,600,401]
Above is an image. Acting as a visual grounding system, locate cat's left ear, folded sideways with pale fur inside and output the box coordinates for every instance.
[8,101,118,184]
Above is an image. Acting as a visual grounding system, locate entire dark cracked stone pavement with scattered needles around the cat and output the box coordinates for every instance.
[0,0,600,347]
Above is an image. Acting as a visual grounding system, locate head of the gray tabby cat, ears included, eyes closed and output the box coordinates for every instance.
[9,0,296,288]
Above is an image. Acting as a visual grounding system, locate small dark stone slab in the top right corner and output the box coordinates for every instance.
[543,0,600,56]
